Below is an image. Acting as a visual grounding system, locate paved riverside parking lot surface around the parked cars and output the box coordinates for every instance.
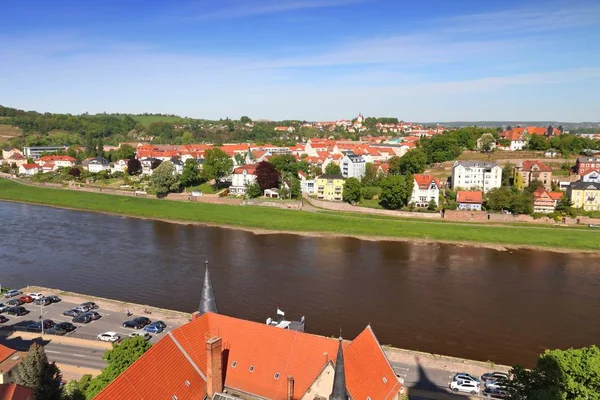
[0,291,186,343]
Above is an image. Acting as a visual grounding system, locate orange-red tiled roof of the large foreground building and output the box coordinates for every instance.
[96,312,401,400]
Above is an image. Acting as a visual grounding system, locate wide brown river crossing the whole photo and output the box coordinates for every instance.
[0,202,600,365]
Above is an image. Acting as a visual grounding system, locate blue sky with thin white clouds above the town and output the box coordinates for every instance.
[0,0,600,121]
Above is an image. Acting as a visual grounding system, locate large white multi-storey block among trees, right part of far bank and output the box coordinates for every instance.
[452,161,502,192]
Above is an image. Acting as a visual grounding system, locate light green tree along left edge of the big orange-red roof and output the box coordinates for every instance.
[86,336,150,399]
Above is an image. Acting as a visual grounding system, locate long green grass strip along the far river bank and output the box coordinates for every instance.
[0,179,600,251]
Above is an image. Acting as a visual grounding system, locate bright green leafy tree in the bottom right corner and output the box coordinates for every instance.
[507,346,600,400]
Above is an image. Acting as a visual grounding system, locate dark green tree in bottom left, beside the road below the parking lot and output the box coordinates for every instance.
[16,342,62,400]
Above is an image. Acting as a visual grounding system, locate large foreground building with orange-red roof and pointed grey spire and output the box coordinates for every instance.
[95,262,402,400]
